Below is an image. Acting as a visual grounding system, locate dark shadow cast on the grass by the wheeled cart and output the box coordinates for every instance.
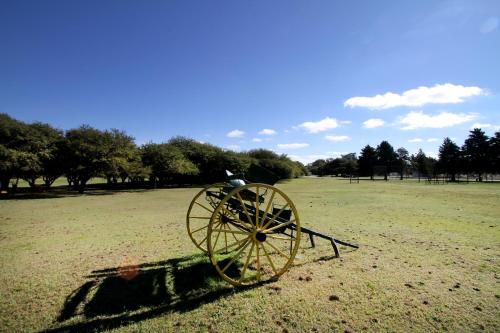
[42,255,262,332]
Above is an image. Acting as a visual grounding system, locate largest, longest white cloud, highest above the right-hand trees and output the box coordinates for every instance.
[344,83,486,109]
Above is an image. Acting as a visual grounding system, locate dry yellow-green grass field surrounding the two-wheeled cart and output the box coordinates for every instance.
[0,178,500,332]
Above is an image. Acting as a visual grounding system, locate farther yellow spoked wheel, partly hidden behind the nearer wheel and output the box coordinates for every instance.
[186,183,228,252]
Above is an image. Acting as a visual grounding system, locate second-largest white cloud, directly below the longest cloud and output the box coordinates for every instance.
[399,111,476,130]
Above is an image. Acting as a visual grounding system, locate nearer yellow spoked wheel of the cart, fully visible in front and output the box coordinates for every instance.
[207,183,300,285]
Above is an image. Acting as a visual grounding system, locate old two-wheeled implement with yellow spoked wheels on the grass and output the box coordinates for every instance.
[186,166,358,286]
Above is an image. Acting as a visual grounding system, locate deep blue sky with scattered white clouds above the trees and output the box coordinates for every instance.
[0,0,500,163]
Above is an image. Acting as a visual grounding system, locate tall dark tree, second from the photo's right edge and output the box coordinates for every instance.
[462,128,489,181]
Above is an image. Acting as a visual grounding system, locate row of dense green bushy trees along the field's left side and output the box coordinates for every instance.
[0,114,307,193]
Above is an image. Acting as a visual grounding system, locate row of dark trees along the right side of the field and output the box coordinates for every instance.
[307,128,500,182]
